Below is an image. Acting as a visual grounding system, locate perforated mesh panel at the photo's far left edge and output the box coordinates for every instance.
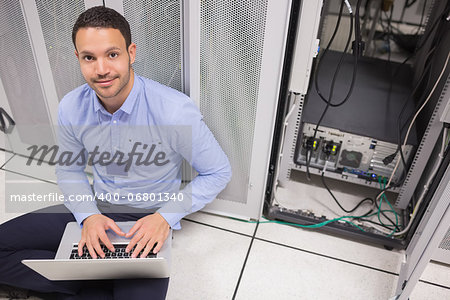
[0,1,53,147]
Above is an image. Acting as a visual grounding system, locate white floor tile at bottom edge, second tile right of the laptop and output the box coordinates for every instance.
[236,240,397,300]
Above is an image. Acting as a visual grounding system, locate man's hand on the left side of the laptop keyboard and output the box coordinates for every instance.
[78,214,125,258]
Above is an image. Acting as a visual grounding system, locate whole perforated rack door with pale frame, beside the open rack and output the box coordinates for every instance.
[199,0,291,218]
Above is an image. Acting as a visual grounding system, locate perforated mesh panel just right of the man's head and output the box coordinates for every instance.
[123,0,183,91]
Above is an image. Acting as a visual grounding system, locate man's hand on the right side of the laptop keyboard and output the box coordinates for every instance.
[125,213,170,258]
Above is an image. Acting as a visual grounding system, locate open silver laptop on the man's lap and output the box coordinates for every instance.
[22,221,172,280]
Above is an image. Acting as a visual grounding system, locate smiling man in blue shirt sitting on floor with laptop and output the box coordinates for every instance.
[0,6,231,299]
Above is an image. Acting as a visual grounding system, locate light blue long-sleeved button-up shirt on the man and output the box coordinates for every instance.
[56,74,231,229]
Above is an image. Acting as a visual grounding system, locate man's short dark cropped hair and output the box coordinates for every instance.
[72,6,131,49]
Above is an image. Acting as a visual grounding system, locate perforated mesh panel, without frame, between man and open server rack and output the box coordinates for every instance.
[200,0,267,203]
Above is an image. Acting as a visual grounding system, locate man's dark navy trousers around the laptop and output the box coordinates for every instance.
[0,205,169,300]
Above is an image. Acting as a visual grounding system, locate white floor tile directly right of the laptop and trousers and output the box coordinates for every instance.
[167,221,251,300]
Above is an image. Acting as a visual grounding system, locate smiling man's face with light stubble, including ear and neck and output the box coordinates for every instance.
[75,27,136,108]
